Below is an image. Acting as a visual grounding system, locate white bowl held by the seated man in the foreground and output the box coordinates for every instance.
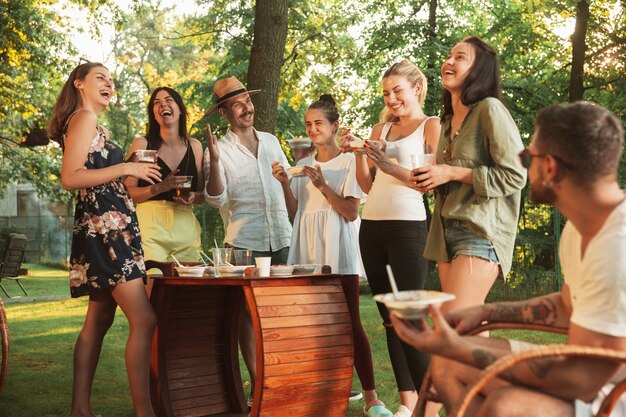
[374,290,456,320]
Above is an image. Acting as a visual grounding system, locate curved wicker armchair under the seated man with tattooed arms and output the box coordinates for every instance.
[413,322,626,417]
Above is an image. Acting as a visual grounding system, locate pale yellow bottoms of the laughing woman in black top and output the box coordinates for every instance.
[137,200,201,262]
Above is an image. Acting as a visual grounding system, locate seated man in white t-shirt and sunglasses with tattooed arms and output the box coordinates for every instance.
[392,102,626,417]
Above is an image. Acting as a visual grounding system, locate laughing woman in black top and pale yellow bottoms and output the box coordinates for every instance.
[126,87,204,294]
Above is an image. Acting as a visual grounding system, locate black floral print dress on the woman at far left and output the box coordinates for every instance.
[70,126,146,297]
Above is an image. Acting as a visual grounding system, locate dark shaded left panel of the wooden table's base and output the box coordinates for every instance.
[152,283,247,417]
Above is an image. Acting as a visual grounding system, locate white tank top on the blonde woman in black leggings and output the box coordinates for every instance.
[361,117,430,220]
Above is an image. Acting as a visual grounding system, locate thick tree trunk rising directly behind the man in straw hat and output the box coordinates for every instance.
[248,0,288,133]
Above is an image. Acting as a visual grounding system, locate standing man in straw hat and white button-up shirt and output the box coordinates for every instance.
[204,77,291,404]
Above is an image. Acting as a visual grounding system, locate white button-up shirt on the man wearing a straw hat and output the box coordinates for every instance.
[204,129,291,251]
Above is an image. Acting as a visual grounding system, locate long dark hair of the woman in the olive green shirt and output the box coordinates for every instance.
[441,36,503,122]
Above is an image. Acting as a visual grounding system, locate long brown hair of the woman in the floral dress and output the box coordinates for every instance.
[48,62,106,148]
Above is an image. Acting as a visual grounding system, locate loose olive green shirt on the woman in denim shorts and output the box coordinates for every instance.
[424,98,526,277]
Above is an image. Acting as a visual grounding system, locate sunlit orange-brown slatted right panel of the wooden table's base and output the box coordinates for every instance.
[249,278,354,417]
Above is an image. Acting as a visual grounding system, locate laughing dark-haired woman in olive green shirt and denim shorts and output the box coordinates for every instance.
[413,37,526,311]
